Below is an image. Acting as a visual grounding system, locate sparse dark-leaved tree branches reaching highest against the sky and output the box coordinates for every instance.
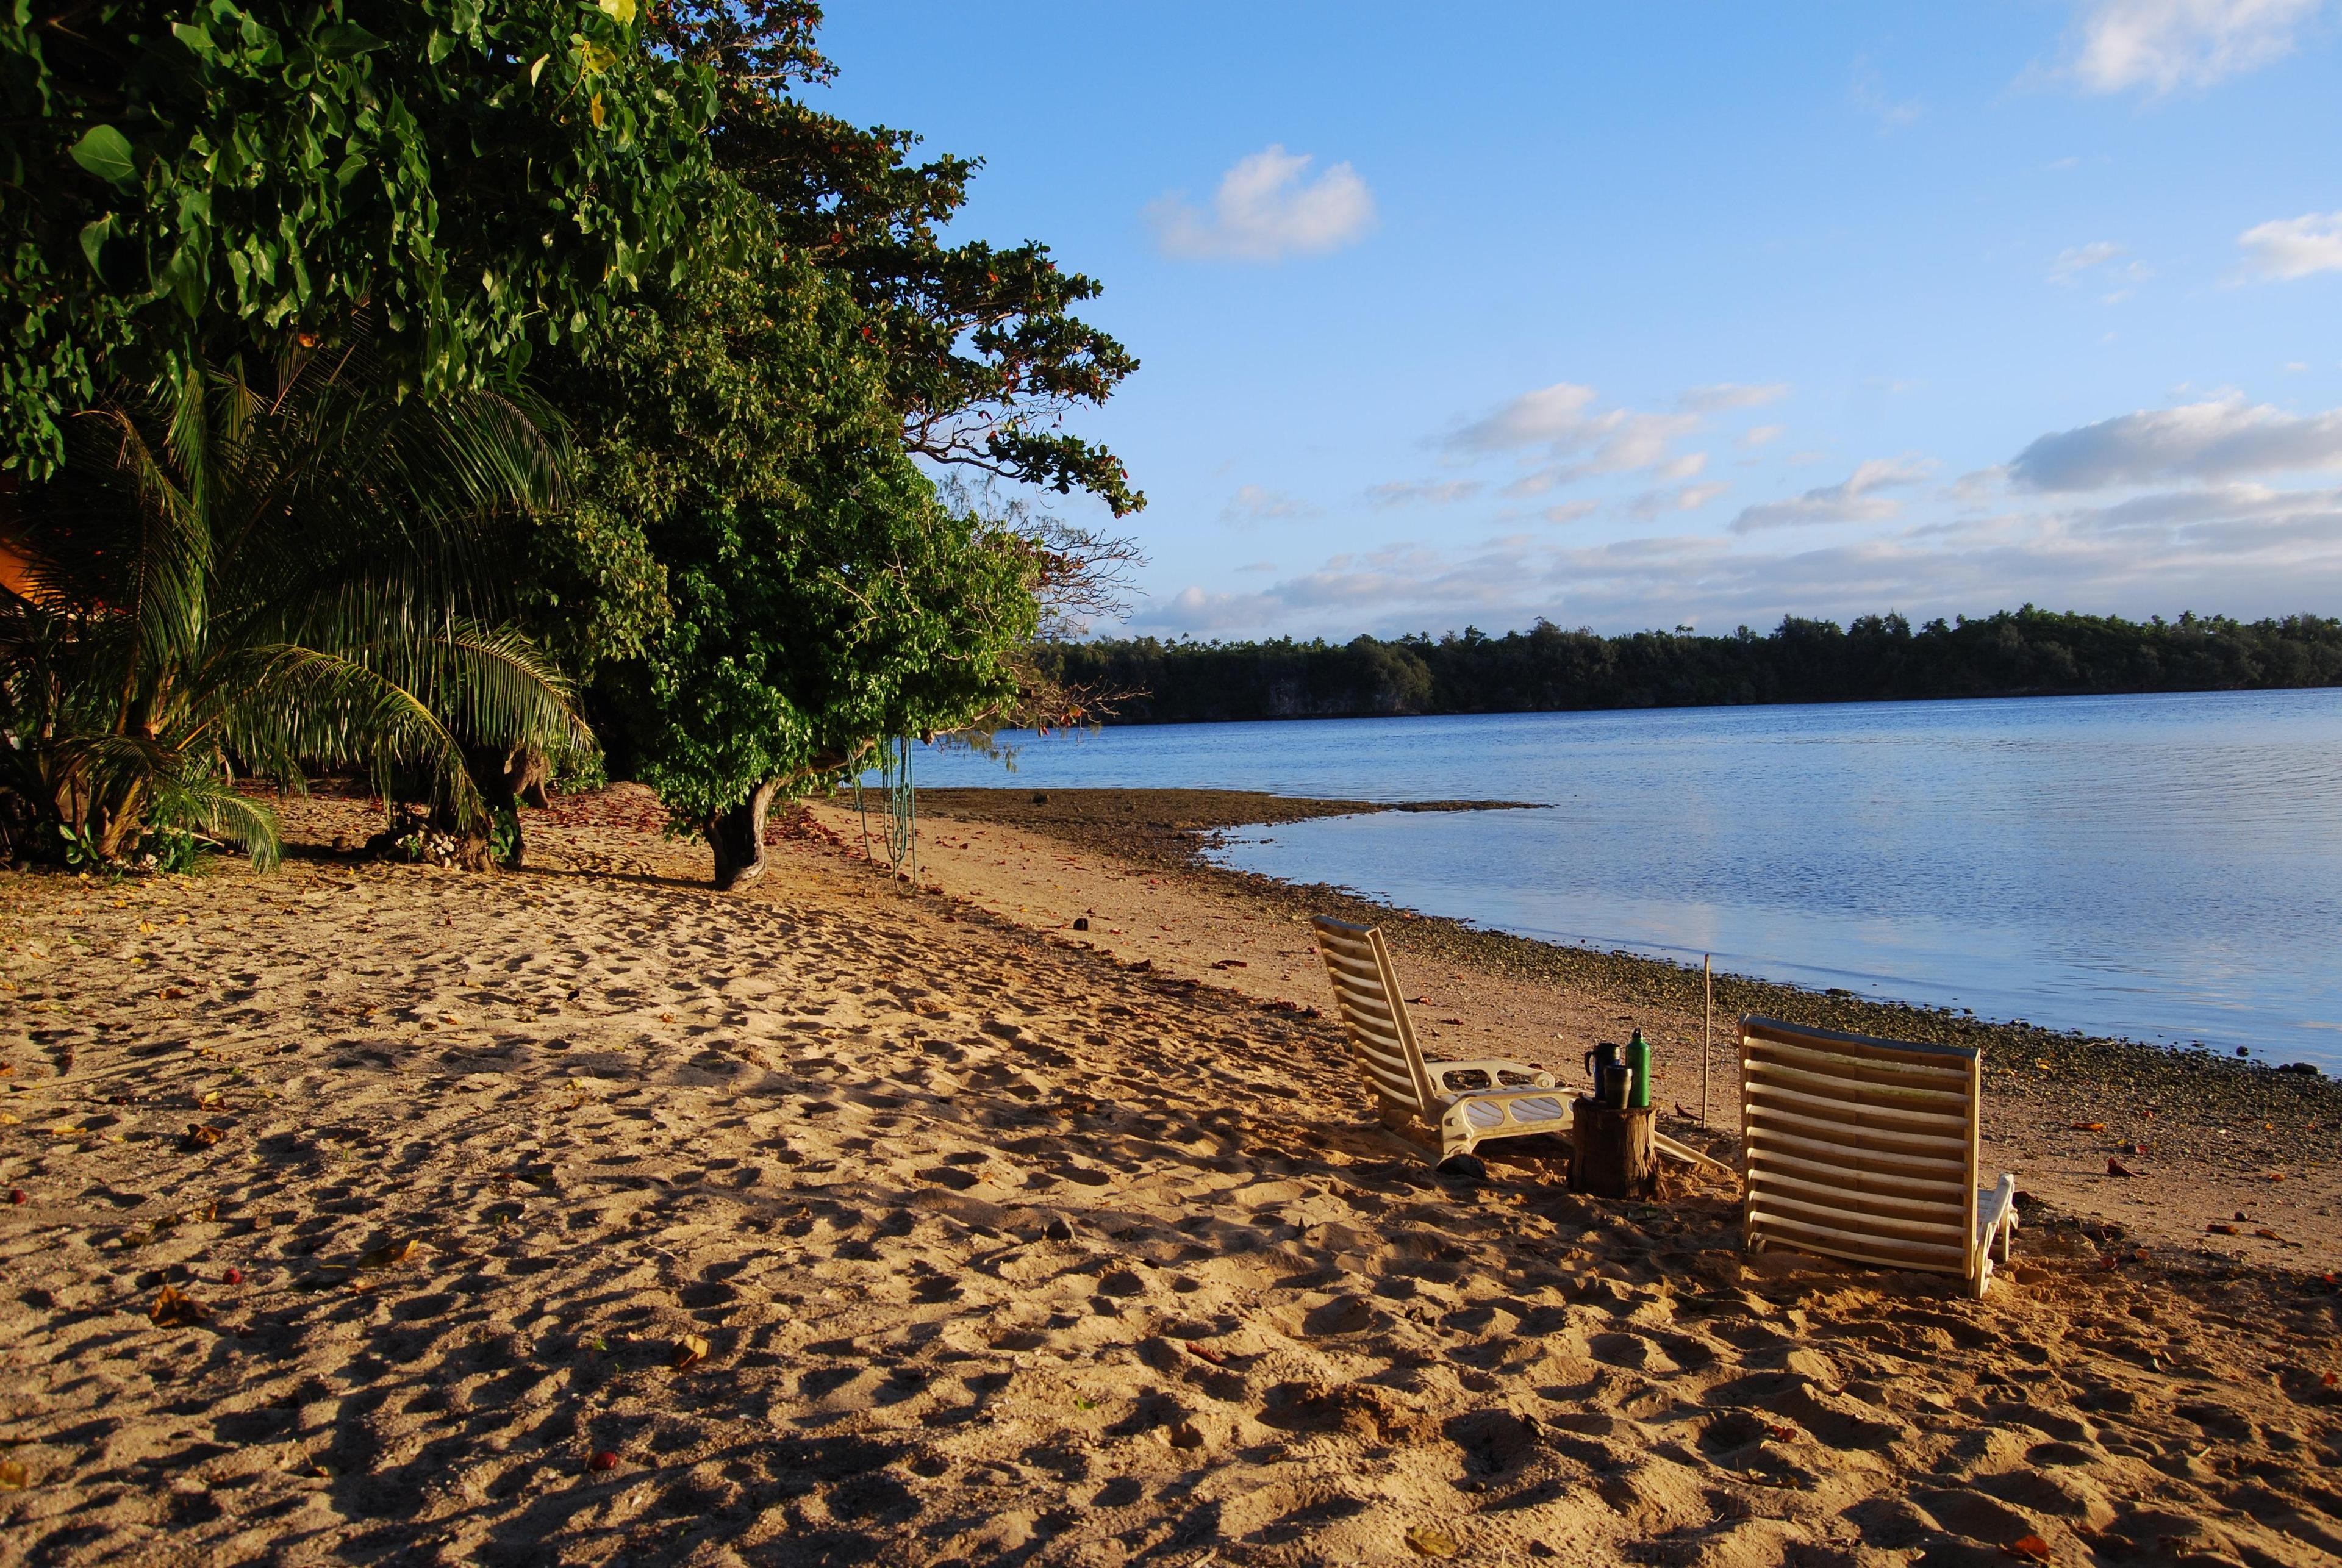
[651,0,1145,517]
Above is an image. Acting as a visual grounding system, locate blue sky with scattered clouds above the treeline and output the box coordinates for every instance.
[812,0,2342,641]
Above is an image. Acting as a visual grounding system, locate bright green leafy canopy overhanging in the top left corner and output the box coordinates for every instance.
[0,0,714,478]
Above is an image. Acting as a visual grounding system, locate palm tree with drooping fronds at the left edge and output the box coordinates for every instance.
[0,342,590,866]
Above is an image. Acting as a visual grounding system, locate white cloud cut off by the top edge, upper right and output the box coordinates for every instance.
[2068,0,2323,93]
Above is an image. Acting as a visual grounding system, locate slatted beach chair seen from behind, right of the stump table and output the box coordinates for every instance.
[1740,1015,2016,1297]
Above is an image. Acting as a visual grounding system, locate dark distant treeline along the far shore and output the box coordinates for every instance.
[1035,604,2342,723]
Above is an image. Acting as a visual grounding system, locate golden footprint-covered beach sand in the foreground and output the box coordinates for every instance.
[0,798,2342,1566]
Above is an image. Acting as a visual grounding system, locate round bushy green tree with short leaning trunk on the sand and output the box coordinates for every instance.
[548,246,1045,887]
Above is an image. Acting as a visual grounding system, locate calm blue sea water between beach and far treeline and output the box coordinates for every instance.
[918,690,2342,1070]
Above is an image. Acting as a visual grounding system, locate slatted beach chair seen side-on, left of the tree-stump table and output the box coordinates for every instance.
[1309,915,1569,1161]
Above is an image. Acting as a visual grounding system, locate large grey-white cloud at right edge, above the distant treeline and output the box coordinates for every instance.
[2010,393,2342,492]
